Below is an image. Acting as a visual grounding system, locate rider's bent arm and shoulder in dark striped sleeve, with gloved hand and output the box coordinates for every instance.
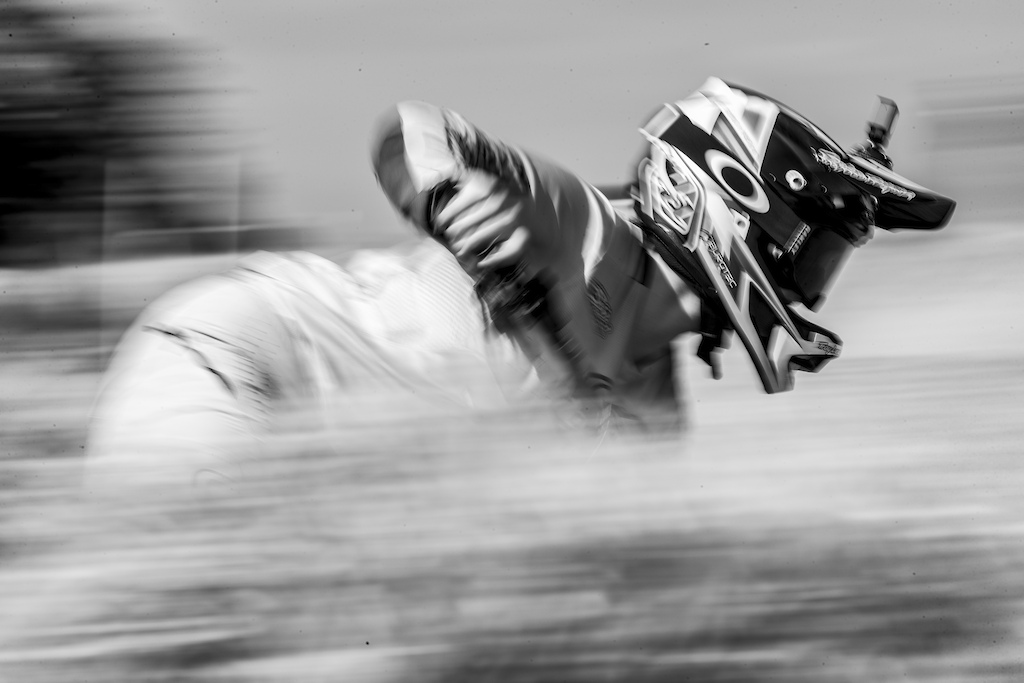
[373,101,699,421]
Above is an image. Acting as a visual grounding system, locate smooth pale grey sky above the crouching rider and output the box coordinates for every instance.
[66,0,1024,241]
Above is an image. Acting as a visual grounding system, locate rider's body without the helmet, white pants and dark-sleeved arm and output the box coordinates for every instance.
[88,93,699,497]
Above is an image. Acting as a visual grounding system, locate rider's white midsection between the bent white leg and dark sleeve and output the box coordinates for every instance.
[234,240,538,407]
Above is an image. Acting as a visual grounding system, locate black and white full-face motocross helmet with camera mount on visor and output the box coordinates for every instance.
[634,78,954,392]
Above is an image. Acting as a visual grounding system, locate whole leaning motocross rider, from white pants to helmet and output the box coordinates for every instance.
[90,79,953,497]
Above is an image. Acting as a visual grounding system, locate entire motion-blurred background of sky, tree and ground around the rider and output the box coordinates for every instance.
[0,0,1024,682]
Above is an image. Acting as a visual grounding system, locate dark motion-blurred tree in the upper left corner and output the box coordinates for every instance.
[0,0,237,265]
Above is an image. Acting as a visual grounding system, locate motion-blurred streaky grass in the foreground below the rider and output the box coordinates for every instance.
[0,228,1024,683]
